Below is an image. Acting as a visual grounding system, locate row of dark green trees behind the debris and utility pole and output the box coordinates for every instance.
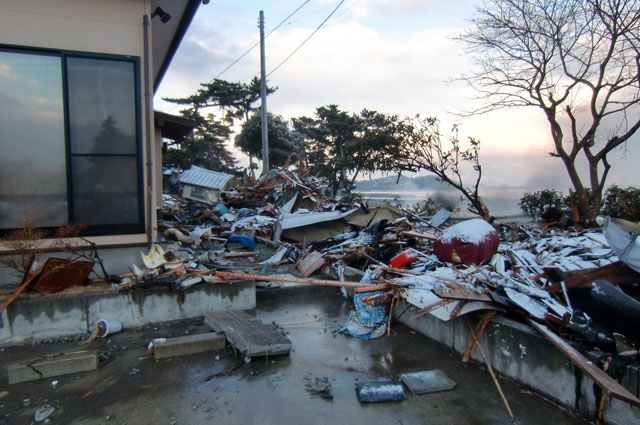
[163,84,488,215]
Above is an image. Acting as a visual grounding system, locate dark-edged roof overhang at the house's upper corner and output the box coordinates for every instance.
[151,0,201,92]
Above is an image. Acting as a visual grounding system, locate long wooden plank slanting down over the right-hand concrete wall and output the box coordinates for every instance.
[527,319,640,407]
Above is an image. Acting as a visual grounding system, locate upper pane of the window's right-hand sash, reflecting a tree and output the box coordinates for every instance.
[67,57,137,154]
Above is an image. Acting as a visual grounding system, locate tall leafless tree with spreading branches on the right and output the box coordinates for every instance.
[458,0,640,220]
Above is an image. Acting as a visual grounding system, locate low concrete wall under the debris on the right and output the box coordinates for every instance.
[396,307,640,425]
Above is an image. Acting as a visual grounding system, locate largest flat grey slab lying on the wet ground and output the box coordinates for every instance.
[204,311,291,357]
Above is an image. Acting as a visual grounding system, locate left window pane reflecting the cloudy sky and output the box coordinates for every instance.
[0,51,68,229]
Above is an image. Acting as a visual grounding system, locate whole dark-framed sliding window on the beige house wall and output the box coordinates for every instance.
[0,49,143,234]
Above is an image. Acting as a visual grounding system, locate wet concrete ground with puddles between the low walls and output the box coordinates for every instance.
[0,287,587,425]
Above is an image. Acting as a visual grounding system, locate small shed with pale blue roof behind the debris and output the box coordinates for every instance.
[180,165,233,203]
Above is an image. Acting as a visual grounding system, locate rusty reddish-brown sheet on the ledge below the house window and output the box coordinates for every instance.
[33,258,94,292]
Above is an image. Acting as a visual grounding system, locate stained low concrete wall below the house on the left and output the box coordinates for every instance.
[0,280,256,346]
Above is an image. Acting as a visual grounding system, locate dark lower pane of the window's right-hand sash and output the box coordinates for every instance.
[72,157,140,225]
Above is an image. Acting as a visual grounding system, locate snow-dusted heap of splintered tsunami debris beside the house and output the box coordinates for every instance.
[160,161,640,415]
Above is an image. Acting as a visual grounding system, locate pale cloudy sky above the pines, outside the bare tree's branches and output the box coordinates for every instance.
[154,0,640,192]
